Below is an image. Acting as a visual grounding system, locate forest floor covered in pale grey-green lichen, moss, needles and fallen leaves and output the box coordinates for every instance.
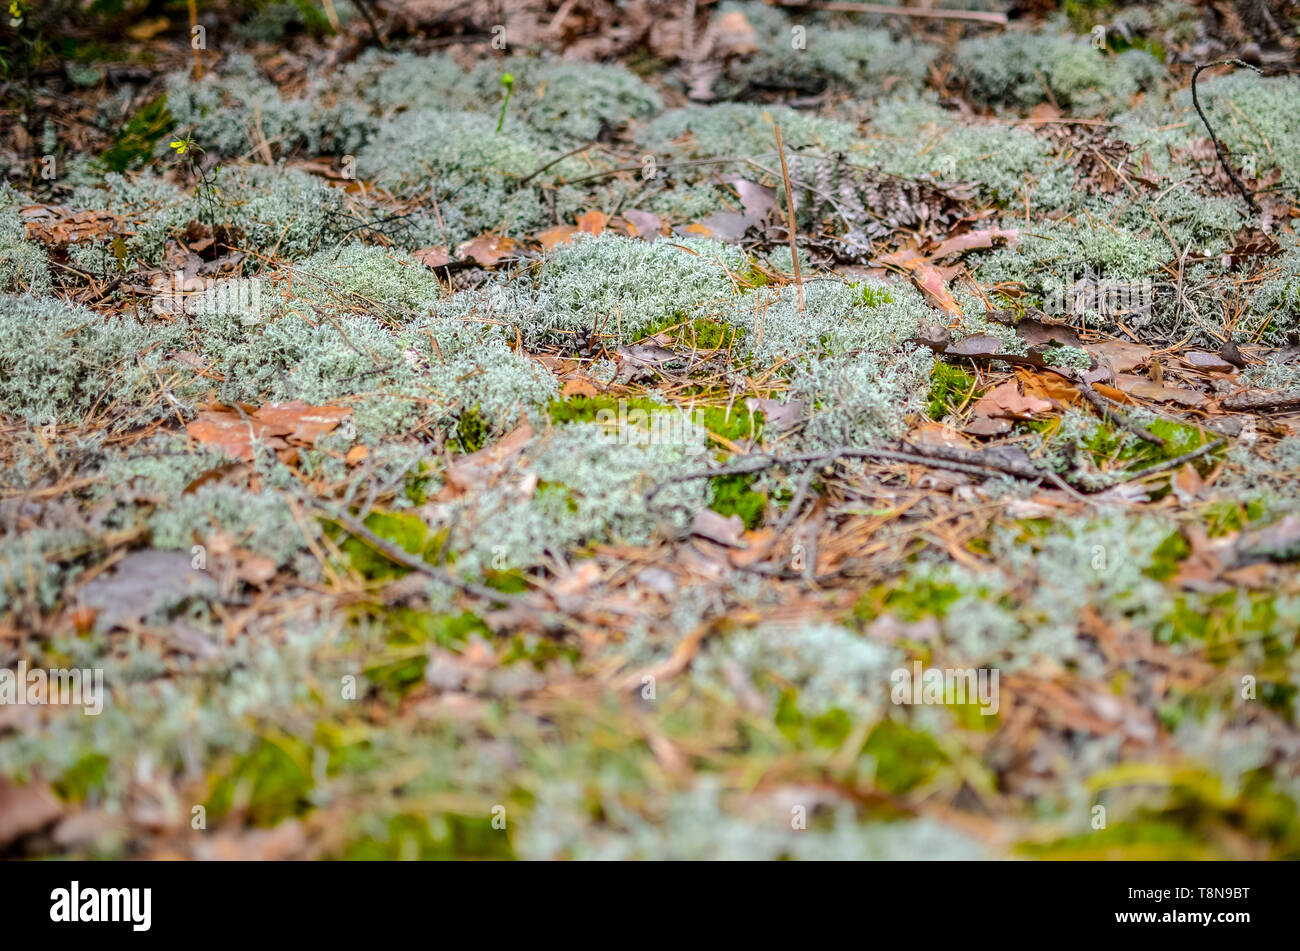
[0,0,1300,859]
